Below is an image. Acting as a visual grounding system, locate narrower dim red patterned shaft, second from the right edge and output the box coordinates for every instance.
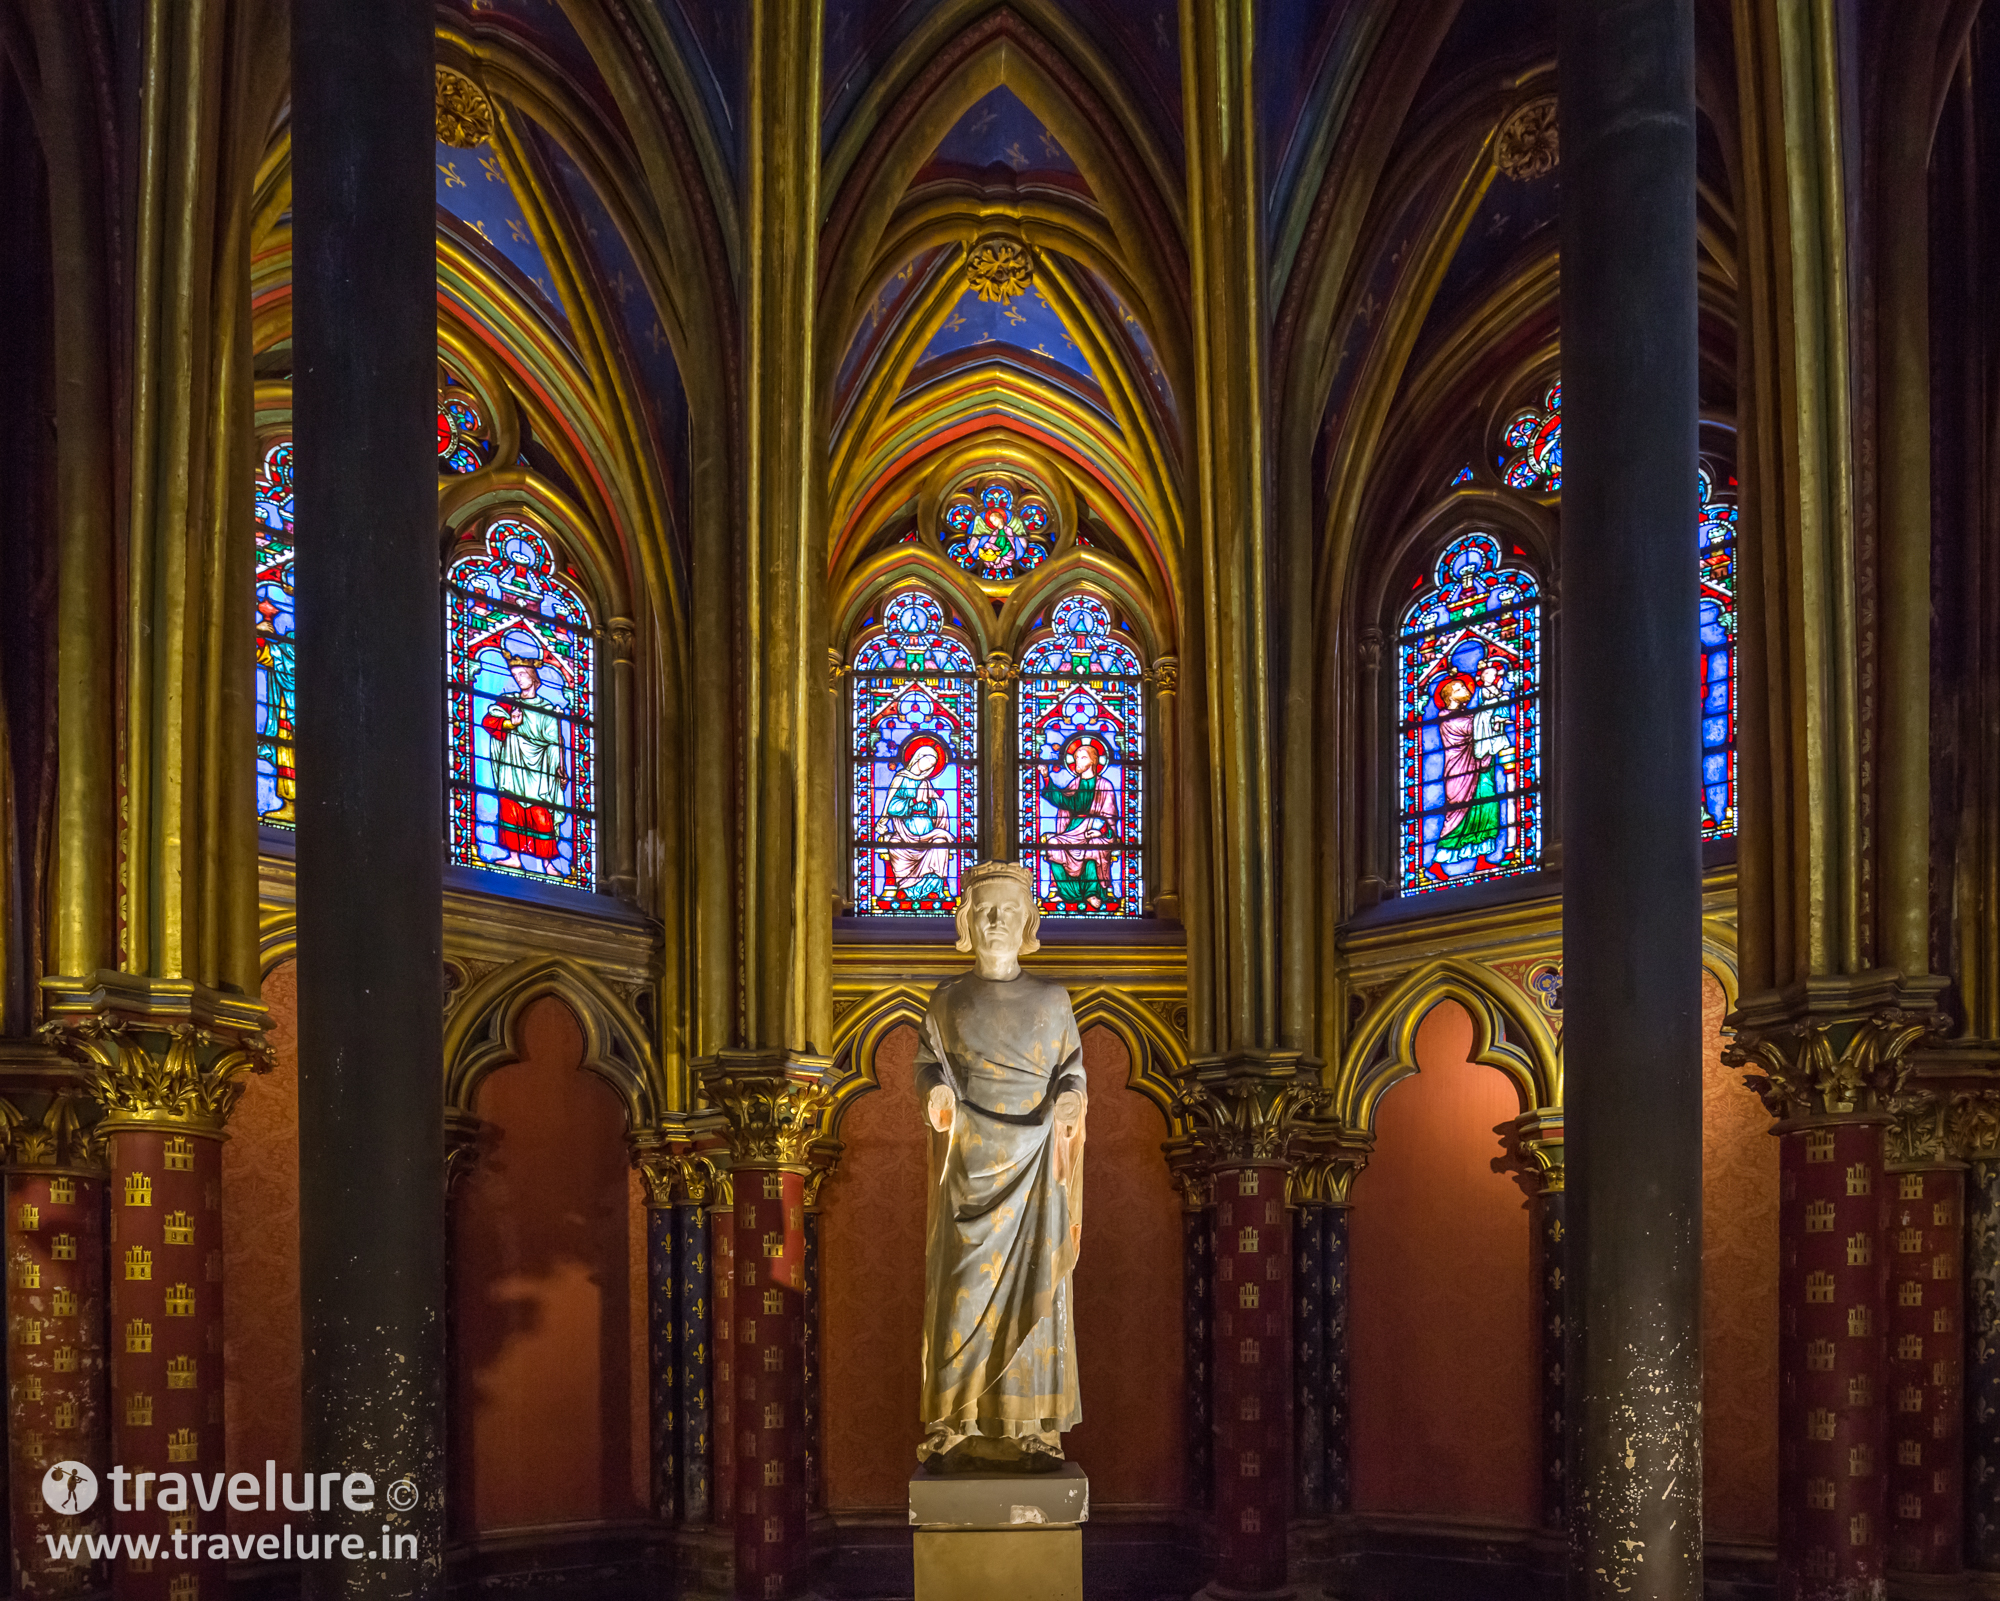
[1886,1167,1966,1573]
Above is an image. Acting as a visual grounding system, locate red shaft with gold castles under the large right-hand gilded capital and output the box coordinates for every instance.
[1778,1119,1888,1601]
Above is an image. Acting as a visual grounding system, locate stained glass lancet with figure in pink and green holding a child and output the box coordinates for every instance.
[1396,534,1542,895]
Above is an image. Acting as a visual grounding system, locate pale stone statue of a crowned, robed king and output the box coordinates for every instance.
[916,863,1086,1471]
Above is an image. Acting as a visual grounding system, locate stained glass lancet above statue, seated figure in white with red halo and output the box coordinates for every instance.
[850,588,980,917]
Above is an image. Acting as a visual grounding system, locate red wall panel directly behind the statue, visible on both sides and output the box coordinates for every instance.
[820,1029,1184,1513]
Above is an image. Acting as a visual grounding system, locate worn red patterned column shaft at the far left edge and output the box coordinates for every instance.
[6,1169,112,1601]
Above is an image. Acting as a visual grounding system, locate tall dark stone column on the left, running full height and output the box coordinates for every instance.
[292,0,446,1597]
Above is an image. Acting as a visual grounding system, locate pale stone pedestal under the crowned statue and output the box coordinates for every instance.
[910,1463,1090,1601]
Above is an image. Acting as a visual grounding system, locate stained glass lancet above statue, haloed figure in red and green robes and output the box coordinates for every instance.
[1016,594,1146,917]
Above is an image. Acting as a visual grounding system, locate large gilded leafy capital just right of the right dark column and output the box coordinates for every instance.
[1722,969,1950,1121]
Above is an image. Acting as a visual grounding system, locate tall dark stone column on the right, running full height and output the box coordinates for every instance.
[1558,0,1702,1601]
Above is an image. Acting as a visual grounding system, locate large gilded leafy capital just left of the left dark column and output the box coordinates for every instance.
[42,973,272,1139]
